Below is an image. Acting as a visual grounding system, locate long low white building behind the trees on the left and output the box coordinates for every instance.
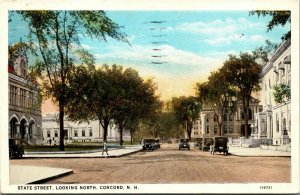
[42,113,130,145]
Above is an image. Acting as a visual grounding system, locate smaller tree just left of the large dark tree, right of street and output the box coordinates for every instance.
[197,70,236,136]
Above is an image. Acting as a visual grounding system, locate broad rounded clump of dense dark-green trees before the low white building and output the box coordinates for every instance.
[66,65,158,144]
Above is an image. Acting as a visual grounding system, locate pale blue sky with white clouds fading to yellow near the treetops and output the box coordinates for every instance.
[9,11,290,99]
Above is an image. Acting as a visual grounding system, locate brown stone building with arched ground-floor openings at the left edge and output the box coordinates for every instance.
[8,45,42,144]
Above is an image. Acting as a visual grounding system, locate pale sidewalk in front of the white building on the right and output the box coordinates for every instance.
[229,146,291,157]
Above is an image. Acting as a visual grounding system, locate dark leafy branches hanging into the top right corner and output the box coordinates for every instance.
[249,10,291,40]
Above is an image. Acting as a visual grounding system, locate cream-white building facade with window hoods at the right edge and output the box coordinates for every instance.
[256,40,291,145]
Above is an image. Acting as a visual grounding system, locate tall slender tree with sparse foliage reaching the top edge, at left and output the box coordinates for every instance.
[17,10,126,150]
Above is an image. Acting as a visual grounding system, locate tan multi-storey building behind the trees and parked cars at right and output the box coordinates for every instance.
[191,98,261,138]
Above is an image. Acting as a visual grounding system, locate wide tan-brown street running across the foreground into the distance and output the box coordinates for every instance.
[10,144,291,184]
